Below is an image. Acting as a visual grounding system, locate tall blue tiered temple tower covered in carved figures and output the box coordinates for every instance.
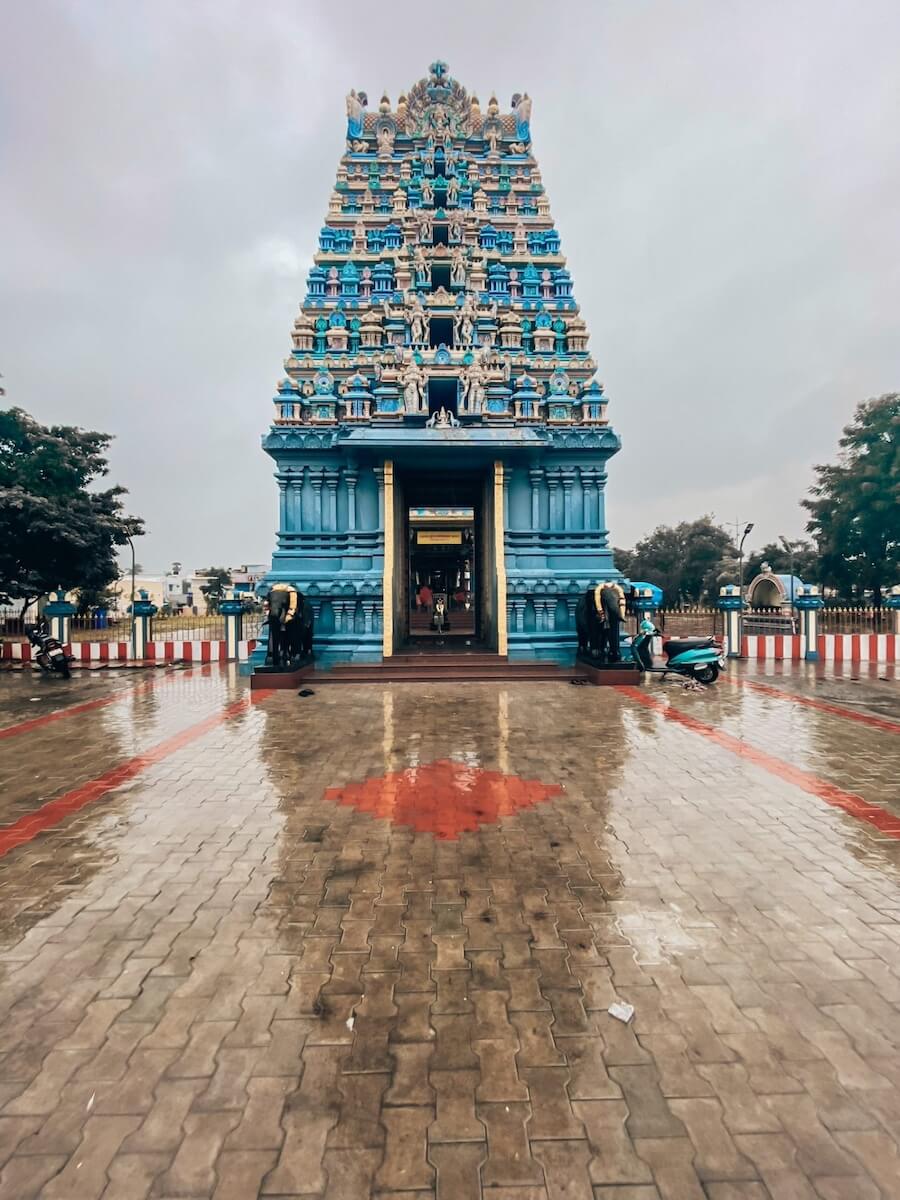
[257,62,620,666]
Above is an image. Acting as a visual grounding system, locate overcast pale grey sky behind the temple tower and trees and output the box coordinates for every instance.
[0,0,900,568]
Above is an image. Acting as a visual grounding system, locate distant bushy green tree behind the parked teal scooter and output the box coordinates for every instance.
[616,516,737,605]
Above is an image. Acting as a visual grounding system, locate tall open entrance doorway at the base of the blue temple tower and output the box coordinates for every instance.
[394,468,497,654]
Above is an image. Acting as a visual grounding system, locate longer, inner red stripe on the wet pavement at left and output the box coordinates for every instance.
[0,688,272,858]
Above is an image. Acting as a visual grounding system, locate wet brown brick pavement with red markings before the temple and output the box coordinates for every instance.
[0,666,900,1200]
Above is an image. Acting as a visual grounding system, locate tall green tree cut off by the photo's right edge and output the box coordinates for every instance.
[803,392,900,605]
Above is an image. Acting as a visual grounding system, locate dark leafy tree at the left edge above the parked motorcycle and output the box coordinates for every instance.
[0,408,144,605]
